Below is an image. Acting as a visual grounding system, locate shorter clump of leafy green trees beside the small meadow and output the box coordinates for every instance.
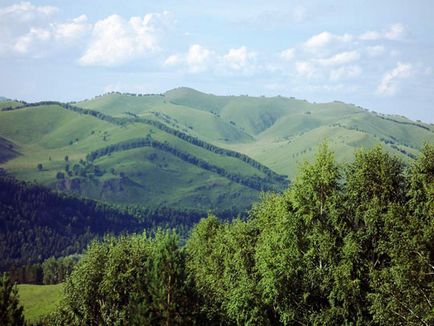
[53,231,195,325]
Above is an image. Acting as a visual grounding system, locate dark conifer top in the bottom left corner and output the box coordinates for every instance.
[0,274,25,326]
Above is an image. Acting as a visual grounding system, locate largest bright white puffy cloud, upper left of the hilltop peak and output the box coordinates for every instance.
[79,12,169,66]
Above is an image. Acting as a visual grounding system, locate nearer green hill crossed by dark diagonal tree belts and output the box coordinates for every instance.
[0,102,287,211]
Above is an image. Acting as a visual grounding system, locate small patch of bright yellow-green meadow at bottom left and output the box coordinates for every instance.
[18,284,63,323]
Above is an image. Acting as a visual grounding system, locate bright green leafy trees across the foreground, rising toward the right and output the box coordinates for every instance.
[3,145,434,325]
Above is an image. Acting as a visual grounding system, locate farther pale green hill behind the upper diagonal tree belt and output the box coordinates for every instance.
[77,88,434,179]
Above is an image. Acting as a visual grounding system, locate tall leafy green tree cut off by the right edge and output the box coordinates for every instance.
[371,145,434,325]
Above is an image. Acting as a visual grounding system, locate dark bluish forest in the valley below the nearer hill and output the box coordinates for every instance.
[0,172,236,272]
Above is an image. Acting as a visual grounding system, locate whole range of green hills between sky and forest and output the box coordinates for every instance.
[0,88,434,211]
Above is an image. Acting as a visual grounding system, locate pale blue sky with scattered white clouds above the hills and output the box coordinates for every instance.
[0,0,434,123]
